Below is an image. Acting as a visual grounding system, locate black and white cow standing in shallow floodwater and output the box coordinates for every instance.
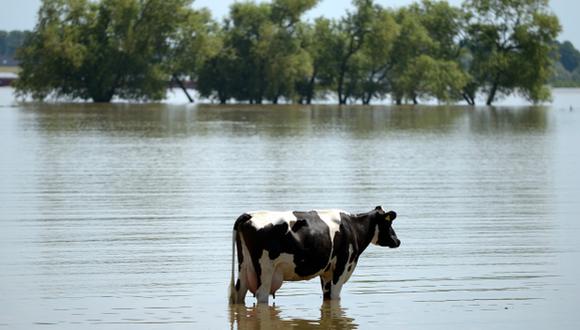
[230,206,401,304]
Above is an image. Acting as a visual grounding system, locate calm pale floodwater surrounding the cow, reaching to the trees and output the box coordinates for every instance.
[0,90,580,329]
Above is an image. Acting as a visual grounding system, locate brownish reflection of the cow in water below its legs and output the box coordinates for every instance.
[230,301,358,329]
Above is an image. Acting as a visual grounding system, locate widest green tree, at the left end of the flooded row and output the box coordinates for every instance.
[15,0,197,102]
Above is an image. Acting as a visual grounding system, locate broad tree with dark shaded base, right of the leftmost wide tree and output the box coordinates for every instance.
[199,0,318,103]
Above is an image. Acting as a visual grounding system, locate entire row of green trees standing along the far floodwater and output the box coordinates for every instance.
[15,0,560,105]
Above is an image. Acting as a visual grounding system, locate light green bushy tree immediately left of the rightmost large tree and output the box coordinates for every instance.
[392,0,469,104]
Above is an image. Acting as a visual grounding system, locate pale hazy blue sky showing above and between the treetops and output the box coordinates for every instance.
[0,0,580,48]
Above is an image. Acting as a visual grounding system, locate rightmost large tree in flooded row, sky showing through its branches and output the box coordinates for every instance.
[464,0,560,105]
